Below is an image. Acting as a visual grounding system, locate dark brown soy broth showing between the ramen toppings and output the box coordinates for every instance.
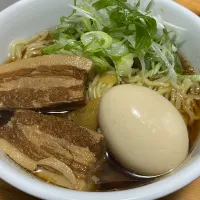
[0,57,200,192]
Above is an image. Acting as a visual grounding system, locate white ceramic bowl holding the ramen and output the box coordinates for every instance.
[0,0,200,200]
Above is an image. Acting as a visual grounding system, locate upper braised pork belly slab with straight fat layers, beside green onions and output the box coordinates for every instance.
[0,55,93,109]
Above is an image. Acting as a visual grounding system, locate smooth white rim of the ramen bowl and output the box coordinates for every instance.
[0,0,200,200]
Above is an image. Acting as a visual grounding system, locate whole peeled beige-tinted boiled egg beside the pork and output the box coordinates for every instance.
[98,85,189,176]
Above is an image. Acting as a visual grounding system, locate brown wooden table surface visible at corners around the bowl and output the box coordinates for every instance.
[0,0,200,200]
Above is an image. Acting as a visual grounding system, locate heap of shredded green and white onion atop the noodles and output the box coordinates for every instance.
[43,0,186,78]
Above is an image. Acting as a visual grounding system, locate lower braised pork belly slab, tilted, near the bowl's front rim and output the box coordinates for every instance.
[0,110,105,190]
